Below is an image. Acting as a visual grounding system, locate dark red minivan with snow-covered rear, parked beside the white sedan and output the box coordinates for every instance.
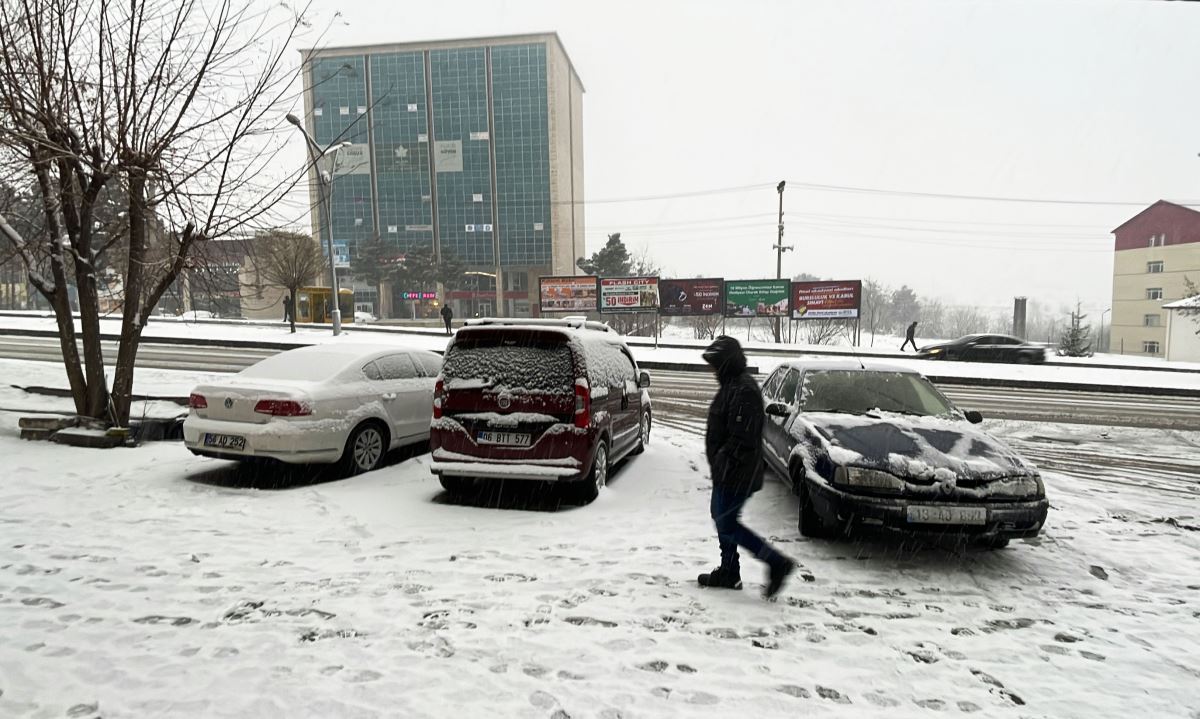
[430,318,652,502]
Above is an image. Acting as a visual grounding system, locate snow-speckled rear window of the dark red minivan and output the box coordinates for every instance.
[442,332,575,394]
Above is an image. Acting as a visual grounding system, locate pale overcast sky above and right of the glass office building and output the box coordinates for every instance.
[288,0,1200,311]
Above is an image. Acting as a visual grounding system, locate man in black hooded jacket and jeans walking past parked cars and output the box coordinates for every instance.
[697,335,796,599]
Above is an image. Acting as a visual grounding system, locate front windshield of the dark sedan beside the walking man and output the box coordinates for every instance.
[800,370,955,417]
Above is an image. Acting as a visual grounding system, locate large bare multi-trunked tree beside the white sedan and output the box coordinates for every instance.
[0,0,308,425]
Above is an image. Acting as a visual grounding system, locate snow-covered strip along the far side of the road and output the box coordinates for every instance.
[0,316,1200,390]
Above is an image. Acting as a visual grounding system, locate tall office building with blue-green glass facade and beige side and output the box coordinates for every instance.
[297,34,583,316]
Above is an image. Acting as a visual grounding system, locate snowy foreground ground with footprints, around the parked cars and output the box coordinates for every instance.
[0,363,1200,719]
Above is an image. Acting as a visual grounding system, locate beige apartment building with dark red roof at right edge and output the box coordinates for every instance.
[1109,200,1200,356]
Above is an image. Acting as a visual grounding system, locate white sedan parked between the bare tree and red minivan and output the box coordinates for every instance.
[184,343,442,474]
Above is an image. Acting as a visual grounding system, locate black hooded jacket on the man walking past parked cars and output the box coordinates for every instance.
[704,336,767,496]
